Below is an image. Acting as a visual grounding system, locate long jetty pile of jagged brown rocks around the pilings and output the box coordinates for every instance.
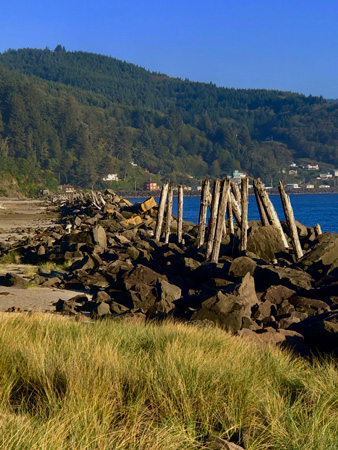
[0,190,338,356]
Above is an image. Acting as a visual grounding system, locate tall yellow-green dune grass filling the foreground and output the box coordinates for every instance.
[0,315,338,450]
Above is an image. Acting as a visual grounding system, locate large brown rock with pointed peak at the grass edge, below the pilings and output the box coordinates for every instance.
[192,273,258,333]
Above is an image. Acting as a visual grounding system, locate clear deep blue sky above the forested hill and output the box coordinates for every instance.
[0,0,338,98]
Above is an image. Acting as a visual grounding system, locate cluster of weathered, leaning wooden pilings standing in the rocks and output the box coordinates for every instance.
[155,177,321,263]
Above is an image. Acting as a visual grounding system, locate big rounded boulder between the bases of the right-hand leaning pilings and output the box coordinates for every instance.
[247,225,285,261]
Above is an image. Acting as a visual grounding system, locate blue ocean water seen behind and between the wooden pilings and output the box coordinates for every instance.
[129,194,338,233]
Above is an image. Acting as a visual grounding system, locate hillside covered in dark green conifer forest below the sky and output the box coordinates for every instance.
[0,45,338,192]
